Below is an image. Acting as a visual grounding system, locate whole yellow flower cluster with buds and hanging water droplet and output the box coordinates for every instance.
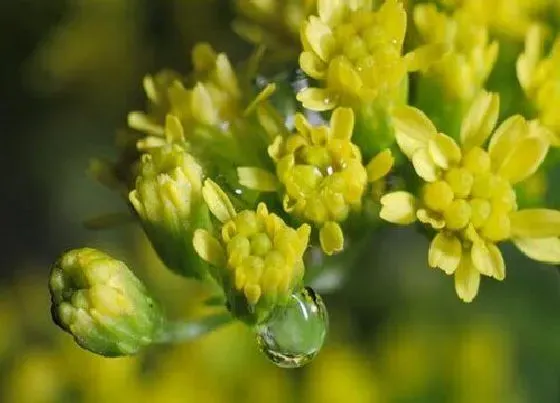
[50,0,560,367]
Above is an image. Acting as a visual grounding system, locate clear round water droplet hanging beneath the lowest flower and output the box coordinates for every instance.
[255,287,329,368]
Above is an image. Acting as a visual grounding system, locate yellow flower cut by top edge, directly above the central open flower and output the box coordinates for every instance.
[297,0,439,111]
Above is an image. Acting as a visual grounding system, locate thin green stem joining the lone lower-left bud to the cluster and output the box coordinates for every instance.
[155,313,233,344]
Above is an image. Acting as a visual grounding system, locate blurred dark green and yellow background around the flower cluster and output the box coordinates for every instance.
[0,0,560,403]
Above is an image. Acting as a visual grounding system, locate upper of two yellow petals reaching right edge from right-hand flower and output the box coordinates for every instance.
[509,209,560,238]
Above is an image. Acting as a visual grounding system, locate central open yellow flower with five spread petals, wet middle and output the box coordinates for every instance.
[237,108,393,255]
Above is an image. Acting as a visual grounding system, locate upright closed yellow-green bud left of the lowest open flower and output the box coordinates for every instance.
[129,145,210,279]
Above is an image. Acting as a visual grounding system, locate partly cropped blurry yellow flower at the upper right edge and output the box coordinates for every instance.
[517,25,560,147]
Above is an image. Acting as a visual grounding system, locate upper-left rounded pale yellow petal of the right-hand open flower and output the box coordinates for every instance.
[391,106,437,159]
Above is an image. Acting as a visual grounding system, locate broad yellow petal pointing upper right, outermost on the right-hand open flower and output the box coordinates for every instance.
[498,137,549,184]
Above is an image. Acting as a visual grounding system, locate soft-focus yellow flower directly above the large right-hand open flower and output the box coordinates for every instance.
[414,4,498,102]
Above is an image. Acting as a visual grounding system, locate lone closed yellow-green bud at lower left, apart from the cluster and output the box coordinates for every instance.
[49,248,164,357]
